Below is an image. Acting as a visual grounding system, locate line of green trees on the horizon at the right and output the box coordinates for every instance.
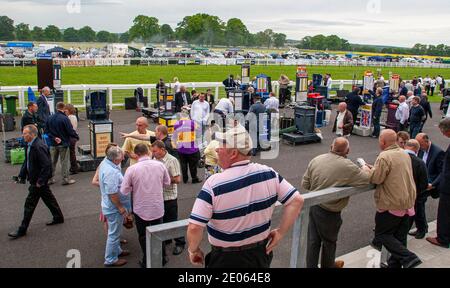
[296,34,450,56]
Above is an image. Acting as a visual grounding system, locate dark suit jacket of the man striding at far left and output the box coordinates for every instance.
[19,138,52,186]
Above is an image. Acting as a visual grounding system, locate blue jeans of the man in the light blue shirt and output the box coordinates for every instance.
[105,212,123,265]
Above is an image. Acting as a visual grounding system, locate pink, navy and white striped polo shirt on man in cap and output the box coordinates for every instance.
[189,161,299,248]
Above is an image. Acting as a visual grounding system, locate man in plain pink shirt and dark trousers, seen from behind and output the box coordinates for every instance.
[120,144,171,267]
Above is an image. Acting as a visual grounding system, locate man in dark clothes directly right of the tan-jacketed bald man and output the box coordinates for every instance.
[405,139,428,239]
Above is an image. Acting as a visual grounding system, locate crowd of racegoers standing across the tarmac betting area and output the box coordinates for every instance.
[9,75,450,268]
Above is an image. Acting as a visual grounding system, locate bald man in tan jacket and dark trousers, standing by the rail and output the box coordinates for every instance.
[364,129,422,268]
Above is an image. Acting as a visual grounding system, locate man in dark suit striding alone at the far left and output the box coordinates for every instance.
[8,125,64,239]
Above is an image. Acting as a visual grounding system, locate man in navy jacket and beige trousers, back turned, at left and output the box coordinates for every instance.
[46,102,80,185]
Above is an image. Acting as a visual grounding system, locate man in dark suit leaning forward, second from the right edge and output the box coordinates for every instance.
[410,133,444,239]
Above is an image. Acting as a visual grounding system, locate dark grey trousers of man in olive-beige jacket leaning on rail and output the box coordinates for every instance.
[306,206,342,268]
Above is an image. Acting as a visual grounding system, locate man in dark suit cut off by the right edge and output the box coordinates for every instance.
[427,117,450,248]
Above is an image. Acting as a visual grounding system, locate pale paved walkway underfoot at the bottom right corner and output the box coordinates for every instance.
[339,221,450,268]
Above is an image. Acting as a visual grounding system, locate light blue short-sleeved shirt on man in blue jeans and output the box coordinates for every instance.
[98,159,131,215]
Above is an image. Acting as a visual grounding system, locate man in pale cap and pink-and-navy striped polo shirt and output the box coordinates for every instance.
[187,127,303,268]
